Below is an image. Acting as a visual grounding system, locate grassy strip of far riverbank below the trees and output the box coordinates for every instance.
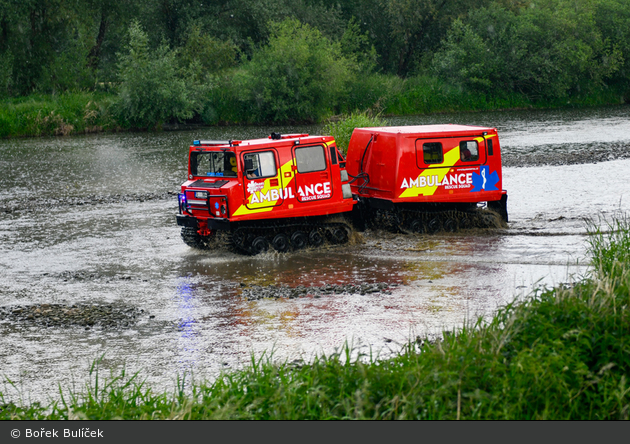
[0,81,624,138]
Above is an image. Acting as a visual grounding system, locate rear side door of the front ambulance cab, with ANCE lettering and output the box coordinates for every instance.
[293,145,333,202]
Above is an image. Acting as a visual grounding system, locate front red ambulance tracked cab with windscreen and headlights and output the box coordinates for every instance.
[177,133,356,254]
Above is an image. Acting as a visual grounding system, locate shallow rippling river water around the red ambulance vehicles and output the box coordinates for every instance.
[0,106,630,402]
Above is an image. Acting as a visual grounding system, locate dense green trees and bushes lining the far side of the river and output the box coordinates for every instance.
[0,0,630,131]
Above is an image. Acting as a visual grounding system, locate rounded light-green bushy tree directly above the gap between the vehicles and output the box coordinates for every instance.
[235,19,356,122]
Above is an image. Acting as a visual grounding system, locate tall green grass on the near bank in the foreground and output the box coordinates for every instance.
[0,219,630,419]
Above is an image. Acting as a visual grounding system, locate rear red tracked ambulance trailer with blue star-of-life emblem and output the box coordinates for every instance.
[346,125,508,233]
